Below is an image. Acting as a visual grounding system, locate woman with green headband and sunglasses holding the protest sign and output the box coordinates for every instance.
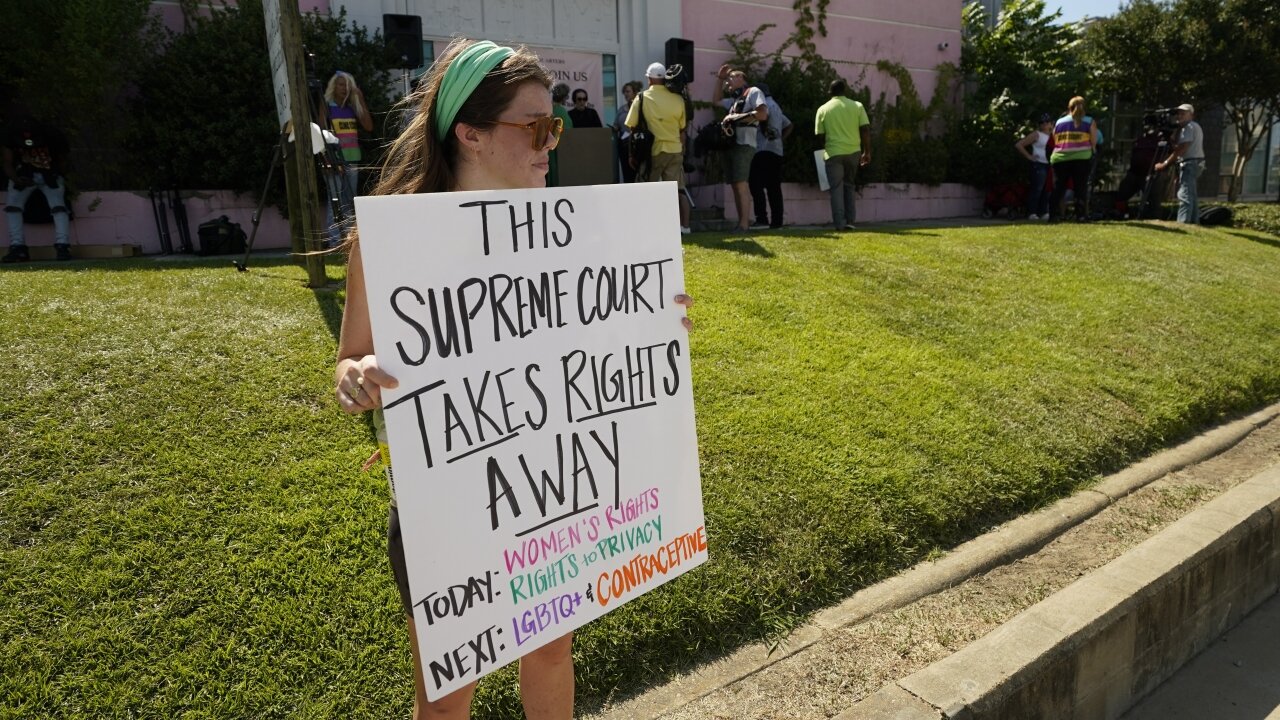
[335,38,692,720]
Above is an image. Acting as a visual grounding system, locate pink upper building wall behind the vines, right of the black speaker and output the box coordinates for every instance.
[681,0,961,110]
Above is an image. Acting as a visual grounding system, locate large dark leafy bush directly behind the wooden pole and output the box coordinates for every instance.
[129,0,394,202]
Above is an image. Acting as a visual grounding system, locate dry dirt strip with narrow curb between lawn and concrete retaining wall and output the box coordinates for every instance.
[586,405,1280,720]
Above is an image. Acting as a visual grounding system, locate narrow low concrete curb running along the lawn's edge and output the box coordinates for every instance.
[598,402,1280,720]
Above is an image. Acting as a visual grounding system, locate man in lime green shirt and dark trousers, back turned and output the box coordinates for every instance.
[813,79,872,231]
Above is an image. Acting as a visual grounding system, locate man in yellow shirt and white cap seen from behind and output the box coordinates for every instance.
[626,63,690,234]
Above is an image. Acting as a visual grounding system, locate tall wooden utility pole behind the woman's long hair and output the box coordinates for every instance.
[262,0,328,287]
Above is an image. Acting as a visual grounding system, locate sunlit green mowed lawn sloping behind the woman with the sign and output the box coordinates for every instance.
[0,224,1280,719]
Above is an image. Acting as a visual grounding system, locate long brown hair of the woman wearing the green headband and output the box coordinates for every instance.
[343,37,552,249]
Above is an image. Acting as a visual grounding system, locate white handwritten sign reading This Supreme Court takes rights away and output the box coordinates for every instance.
[356,183,707,700]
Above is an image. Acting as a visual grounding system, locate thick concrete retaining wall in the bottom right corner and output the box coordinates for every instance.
[836,464,1280,720]
